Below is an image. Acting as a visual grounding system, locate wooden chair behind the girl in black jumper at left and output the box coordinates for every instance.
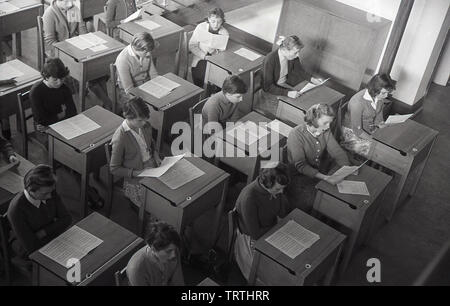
[17,91,47,159]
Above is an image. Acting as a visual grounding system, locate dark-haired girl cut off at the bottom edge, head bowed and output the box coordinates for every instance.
[127,222,184,286]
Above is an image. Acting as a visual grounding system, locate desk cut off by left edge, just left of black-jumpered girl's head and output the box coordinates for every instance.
[0,59,41,119]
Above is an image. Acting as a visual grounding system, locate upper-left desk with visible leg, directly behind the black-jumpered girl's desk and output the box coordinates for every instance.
[54,31,125,112]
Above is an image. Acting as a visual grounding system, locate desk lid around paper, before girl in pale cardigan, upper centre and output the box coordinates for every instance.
[130,72,203,110]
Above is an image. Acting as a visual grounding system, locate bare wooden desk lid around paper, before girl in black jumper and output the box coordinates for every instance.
[46,105,124,152]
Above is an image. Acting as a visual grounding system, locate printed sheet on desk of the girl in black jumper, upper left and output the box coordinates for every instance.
[50,114,100,139]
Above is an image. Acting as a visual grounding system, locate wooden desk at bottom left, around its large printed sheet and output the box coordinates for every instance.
[30,212,144,286]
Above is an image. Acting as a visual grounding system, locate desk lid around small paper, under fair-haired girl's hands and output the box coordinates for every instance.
[316,165,392,209]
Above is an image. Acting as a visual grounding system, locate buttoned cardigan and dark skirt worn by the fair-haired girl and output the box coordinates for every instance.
[287,124,350,212]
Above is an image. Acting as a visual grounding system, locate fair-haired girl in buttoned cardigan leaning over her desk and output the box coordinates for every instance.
[287,104,350,213]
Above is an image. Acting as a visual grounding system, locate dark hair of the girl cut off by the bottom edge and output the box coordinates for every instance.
[145,221,181,251]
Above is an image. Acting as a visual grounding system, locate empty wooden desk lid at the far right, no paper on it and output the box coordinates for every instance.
[373,119,438,155]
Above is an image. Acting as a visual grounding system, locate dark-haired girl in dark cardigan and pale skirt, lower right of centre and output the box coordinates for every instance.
[234,163,290,280]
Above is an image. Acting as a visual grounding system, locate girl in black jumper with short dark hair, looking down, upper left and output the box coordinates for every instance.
[30,58,77,144]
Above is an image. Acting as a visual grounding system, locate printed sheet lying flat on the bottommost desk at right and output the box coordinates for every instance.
[266,220,320,259]
